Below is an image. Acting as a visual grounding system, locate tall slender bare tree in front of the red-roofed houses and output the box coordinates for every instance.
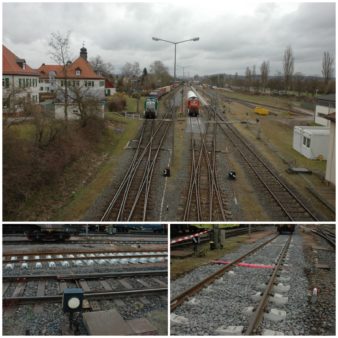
[48,31,70,122]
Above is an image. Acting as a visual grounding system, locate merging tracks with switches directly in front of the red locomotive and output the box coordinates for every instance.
[182,111,231,221]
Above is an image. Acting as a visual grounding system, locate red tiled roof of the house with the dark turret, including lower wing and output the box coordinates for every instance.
[38,57,104,80]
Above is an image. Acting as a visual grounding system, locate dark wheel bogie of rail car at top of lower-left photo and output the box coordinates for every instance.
[25,224,80,242]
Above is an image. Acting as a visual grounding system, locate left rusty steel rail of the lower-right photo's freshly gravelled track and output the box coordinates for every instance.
[170,235,279,311]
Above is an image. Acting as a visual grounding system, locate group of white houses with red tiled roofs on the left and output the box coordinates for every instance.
[2,45,115,118]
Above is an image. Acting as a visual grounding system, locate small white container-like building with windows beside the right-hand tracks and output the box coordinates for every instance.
[293,126,330,160]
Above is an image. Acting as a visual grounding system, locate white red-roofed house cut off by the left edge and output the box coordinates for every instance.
[2,45,39,113]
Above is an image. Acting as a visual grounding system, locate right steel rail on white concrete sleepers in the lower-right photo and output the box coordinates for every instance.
[245,235,292,336]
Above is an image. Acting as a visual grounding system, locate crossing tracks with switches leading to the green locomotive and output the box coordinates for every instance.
[101,108,172,221]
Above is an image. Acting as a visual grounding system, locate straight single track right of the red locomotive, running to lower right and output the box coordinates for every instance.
[211,108,318,221]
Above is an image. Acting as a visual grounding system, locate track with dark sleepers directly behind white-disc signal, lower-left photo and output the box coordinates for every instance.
[2,270,167,307]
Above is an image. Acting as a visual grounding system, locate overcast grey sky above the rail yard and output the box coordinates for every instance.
[2,0,336,76]
